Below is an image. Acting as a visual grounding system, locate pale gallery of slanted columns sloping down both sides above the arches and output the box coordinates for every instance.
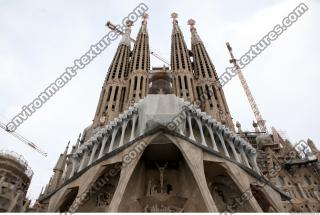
[69,95,260,178]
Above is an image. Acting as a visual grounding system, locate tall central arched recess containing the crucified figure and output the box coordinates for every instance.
[119,135,207,212]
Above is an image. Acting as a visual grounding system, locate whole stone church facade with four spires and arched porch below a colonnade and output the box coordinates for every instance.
[2,13,320,212]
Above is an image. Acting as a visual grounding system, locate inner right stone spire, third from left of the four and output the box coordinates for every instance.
[171,13,195,102]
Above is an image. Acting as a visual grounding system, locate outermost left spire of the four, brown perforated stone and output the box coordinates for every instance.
[93,21,132,127]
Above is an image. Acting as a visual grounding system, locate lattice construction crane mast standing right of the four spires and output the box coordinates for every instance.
[226,43,268,133]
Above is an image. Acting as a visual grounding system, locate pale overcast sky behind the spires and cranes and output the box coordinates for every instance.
[0,0,320,201]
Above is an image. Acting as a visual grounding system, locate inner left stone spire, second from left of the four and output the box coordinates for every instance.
[126,13,150,107]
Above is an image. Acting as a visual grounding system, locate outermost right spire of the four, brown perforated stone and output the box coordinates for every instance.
[188,19,234,130]
